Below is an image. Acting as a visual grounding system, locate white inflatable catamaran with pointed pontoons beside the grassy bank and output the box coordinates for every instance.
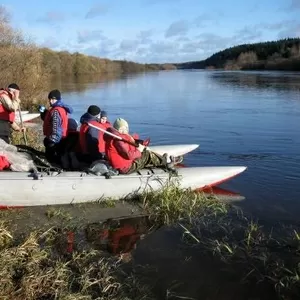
[0,144,247,207]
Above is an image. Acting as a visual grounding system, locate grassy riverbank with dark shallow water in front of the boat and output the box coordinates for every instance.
[0,182,300,299]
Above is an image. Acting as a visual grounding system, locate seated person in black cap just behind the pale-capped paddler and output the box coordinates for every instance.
[79,105,106,163]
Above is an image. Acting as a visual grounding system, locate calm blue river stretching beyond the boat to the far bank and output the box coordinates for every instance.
[57,70,300,219]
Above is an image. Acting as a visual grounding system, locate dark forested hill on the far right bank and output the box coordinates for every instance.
[175,38,300,71]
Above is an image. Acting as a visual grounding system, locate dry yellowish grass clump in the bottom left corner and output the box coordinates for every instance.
[0,223,155,300]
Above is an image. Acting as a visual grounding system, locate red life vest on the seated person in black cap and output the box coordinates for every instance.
[79,120,106,154]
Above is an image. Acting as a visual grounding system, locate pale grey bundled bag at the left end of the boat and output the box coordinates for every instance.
[0,139,36,172]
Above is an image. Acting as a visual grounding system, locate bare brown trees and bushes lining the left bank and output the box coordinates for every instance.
[0,5,176,109]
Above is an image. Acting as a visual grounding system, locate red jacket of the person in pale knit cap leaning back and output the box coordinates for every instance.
[104,127,142,173]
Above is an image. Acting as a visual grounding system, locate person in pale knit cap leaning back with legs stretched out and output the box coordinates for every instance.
[104,118,174,174]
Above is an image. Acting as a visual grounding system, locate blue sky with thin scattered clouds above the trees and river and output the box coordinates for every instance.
[1,0,300,63]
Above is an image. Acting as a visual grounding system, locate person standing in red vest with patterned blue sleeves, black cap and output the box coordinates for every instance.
[39,90,73,164]
